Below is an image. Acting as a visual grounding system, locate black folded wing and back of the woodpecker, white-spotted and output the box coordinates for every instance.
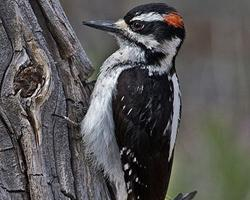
[113,68,176,200]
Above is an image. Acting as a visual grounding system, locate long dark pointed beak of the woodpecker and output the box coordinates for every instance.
[82,20,120,33]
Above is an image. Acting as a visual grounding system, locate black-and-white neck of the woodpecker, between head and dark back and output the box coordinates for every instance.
[100,39,180,75]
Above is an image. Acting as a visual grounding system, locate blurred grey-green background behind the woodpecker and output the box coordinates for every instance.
[61,0,250,200]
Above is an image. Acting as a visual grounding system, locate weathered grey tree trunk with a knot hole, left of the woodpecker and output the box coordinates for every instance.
[0,0,110,200]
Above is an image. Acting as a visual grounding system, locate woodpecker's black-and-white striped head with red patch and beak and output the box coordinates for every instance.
[83,3,185,65]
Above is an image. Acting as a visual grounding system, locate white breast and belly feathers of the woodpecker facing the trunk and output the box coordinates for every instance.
[81,47,144,200]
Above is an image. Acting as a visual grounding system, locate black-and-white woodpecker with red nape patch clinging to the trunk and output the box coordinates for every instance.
[81,3,185,200]
